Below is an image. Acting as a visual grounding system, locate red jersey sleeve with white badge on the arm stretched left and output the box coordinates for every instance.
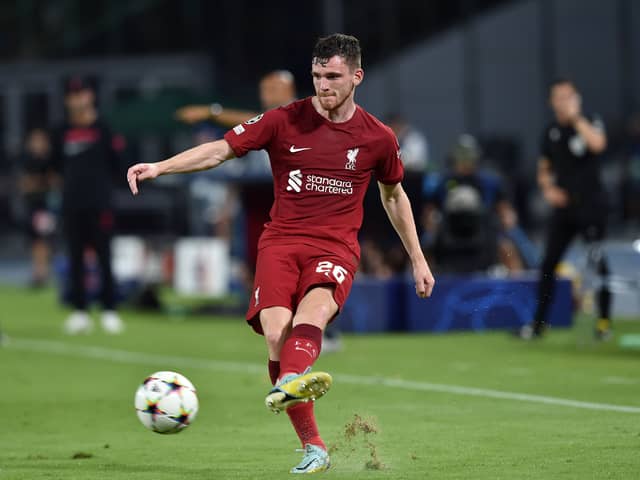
[224,109,283,157]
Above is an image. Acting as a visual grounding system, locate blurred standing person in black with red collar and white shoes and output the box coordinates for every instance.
[52,77,124,334]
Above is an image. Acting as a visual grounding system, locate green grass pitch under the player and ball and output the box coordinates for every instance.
[0,287,640,480]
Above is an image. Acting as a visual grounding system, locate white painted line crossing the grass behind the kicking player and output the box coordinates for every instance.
[6,339,640,413]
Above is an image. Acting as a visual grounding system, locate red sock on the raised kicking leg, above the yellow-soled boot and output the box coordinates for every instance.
[280,323,322,377]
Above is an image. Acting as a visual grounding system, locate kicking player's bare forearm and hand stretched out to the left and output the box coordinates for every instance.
[127,140,235,195]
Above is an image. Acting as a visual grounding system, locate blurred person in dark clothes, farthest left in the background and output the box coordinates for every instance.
[19,128,56,287]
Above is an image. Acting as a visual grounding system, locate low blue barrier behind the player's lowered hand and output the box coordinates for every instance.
[336,276,573,333]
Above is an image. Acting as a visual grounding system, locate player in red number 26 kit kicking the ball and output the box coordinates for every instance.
[127,34,434,473]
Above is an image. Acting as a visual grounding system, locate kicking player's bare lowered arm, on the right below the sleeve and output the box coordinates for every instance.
[378,182,435,298]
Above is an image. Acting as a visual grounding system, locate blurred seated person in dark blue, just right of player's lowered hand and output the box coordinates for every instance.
[422,134,535,273]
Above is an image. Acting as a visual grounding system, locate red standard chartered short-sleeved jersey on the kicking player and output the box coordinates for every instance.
[224,97,403,259]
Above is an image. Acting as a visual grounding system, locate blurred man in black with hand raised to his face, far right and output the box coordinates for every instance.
[519,79,611,339]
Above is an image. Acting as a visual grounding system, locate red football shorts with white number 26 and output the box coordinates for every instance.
[247,244,357,335]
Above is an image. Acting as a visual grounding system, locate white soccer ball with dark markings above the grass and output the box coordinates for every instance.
[135,372,198,433]
